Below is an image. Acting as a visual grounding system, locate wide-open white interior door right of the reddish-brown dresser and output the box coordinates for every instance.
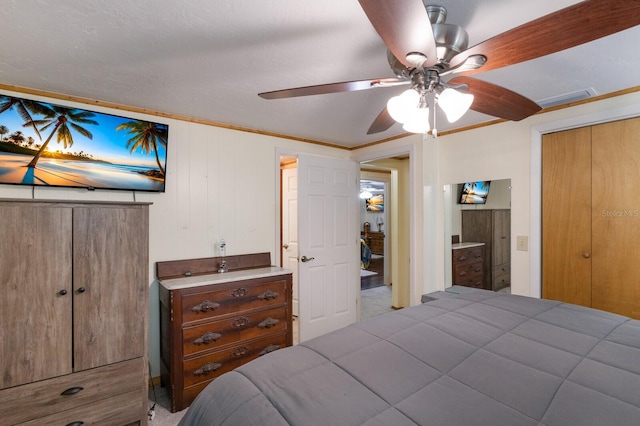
[298,155,360,341]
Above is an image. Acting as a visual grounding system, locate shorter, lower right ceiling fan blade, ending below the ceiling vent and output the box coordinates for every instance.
[447,76,542,121]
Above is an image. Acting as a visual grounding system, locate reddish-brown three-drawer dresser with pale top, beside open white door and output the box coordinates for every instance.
[157,253,293,412]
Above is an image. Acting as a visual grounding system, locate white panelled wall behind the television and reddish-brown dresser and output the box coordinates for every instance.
[0,87,350,377]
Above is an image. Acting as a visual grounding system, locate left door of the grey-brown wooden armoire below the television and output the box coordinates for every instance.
[0,202,73,388]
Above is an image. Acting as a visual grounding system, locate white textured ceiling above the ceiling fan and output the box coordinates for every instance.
[0,0,640,147]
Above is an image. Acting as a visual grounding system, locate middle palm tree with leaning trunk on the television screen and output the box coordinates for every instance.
[25,105,98,167]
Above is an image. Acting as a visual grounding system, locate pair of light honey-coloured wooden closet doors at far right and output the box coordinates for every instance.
[542,118,640,318]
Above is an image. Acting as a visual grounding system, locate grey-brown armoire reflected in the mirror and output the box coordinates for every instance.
[462,209,511,291]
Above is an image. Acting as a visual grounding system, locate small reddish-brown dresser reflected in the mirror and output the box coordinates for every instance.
[451,242,485,288]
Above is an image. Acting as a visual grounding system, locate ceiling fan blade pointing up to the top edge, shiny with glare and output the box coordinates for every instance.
[359,0,437,68]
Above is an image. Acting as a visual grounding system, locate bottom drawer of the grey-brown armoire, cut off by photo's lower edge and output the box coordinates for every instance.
[20,389,145,426]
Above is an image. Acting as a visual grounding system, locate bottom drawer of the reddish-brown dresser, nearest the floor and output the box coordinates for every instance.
[183,333,287,388]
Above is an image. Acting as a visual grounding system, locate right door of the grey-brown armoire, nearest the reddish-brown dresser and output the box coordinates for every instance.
[73,206,149,371]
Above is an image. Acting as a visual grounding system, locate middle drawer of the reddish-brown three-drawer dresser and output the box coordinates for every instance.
[182,307,287,356]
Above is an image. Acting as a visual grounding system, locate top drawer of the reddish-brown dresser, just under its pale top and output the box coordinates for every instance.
[182,278,287,323]
